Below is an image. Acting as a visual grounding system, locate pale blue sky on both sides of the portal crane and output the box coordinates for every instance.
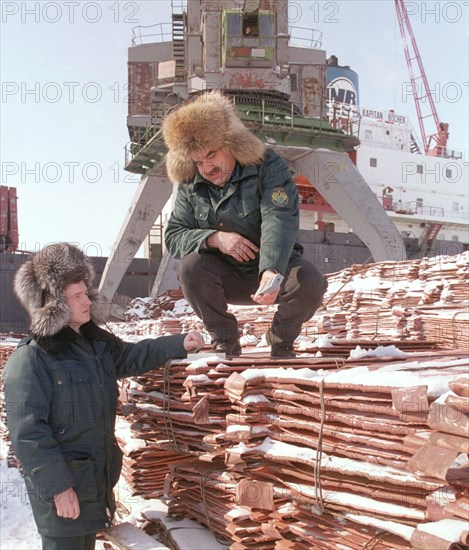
[0,0,469,256]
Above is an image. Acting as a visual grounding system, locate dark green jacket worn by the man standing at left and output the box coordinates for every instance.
[4,321,186,537]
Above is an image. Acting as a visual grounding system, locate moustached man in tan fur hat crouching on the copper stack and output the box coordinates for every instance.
[163,91,327,359]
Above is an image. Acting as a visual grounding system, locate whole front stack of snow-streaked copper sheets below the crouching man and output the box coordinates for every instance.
[121,351,469,550]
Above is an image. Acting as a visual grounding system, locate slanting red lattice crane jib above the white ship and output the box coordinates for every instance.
[394,0,448,157]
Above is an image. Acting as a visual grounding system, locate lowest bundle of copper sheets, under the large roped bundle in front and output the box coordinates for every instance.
[166,458,410,550]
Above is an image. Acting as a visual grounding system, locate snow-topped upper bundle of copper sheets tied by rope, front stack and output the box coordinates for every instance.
[218,355,469,548]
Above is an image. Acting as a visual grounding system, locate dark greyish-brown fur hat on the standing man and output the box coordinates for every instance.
[14,243,109,337]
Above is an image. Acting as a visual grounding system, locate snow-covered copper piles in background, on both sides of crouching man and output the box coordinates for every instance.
[114,252,469,351]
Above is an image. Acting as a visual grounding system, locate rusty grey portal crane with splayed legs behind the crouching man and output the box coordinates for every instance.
[101,0,405,320]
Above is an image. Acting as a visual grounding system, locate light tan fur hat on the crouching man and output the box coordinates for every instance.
[162,90,266,183]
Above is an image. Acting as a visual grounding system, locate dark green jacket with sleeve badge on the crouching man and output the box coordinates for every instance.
[165,149,303,274]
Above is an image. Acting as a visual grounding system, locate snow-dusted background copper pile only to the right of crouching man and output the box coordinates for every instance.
[322,252,469,348]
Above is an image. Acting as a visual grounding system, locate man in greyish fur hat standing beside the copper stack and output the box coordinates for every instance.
[4,243,203,550]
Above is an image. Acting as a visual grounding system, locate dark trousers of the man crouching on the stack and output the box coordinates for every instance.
[178,252,327,344]
